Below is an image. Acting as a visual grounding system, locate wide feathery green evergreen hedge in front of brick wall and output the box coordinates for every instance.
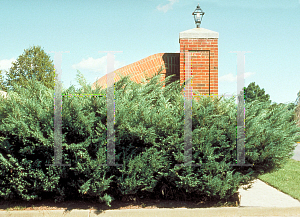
[0,67,300,205]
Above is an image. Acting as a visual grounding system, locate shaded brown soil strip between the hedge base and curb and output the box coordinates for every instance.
[0,193,239,211]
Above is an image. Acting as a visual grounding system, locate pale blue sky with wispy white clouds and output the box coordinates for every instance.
[0,0,300,103]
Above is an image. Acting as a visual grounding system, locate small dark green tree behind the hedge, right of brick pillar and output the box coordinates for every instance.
[244,82,271,103]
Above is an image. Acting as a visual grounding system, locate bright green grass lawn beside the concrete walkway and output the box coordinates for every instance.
[258,159,300,201]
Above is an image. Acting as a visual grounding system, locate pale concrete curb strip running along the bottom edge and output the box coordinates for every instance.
[0,207,300,217]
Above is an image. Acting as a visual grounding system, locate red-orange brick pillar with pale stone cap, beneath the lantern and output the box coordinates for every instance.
[179,28,219,98]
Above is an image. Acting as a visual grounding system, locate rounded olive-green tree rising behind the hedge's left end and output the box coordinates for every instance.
[5,46,54,90]
